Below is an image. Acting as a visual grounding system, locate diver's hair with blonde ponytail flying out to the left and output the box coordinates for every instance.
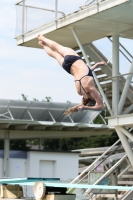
[64,97,96,116]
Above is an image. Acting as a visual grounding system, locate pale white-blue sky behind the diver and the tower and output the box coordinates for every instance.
[0,0,133,102]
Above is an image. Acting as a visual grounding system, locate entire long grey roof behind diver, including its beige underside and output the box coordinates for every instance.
[0,99,114,139]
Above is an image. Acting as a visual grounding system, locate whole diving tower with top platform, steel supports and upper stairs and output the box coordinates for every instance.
[13,0,133,198]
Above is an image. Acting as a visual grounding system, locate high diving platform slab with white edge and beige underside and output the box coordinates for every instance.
[16,0,133,48]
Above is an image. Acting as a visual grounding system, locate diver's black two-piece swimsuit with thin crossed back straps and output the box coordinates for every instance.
[62,55,93,94]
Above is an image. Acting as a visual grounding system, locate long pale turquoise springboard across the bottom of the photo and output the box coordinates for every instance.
[0,178,133,191]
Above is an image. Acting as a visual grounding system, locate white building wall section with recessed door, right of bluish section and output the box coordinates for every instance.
[27,151,78,180]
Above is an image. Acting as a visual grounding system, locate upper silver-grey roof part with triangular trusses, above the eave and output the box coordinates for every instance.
[0,100,99,124]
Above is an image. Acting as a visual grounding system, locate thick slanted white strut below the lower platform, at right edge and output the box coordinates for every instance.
[115,127,133,166]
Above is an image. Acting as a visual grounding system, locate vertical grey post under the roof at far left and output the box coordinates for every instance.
[3,131,10,177]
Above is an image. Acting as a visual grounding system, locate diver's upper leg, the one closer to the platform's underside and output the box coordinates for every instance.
[38,35,78,57]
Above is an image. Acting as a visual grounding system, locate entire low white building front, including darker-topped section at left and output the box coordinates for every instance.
[0,151,78,180]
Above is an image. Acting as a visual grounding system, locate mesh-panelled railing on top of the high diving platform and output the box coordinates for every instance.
[16,0,106,36]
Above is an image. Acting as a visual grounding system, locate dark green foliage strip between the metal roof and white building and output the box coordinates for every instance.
[42,132,118,151]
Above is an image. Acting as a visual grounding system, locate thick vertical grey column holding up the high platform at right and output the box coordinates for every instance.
[112,35,119,116]
